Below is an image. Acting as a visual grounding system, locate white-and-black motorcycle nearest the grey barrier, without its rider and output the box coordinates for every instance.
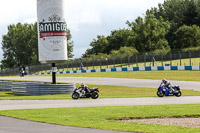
[72,87,99,99]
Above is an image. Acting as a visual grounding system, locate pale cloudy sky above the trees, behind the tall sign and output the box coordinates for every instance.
[0,0,164,61]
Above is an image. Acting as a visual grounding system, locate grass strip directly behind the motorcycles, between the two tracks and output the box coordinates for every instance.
[0,84,200,100]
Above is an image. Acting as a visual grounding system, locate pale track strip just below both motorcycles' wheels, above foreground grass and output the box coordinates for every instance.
[0,96,200,110]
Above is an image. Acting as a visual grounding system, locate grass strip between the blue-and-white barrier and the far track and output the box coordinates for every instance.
[54,71,200,81]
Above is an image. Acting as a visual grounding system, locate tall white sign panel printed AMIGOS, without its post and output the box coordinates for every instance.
[37,0,67,63]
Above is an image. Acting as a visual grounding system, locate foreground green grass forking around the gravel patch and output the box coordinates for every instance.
[0,104,200,133]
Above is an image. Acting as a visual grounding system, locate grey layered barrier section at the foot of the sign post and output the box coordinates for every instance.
[0,81,75,95]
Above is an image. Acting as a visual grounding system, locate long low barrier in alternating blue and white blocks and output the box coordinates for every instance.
[35,66,200,75]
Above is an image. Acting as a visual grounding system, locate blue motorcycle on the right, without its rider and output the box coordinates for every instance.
[157,85,181,97]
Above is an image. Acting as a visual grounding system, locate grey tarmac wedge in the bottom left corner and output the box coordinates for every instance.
[0,116,128,133]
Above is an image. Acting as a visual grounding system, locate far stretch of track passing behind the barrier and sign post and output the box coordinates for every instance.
[1,76,200,91]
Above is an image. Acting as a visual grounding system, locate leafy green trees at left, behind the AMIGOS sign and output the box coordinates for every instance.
[1,22,73,69]
